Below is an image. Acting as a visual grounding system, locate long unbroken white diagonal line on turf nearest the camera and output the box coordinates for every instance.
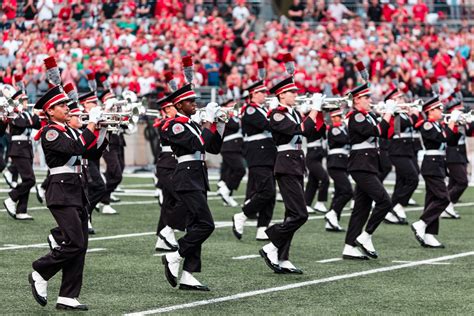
[124,251,474,316]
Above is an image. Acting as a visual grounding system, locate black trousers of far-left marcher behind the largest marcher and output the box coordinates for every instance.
[9,157,36,214]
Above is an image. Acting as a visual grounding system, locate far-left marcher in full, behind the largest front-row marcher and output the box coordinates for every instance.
[3,86,41,220]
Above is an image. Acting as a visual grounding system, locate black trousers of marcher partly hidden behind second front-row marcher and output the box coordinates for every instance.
[156,168,186,235]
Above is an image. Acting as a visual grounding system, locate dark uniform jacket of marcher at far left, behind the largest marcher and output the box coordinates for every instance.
[9,112,41,159]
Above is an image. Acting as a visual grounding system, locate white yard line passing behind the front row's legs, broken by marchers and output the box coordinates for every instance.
[0,201,474,251]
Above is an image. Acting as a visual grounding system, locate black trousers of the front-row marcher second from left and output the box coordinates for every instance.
[178,191,215,273]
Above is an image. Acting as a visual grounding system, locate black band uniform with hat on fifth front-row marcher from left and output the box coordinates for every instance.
[412,97,461,241]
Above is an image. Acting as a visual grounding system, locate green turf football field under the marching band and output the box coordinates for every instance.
[0,177,474,315]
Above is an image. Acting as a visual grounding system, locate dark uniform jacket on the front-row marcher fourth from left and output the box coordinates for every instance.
[348,109,393,173]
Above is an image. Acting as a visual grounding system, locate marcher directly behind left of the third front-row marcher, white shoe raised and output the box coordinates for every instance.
[232,80,276,240]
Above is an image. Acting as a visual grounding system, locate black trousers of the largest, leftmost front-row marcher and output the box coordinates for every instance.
[33,206,88,298]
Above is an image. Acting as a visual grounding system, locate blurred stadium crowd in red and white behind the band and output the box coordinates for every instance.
[0,0,474,102]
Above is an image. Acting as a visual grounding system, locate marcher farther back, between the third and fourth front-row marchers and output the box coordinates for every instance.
[324,108,353,232]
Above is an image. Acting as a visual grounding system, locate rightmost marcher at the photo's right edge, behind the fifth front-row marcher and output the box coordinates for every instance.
[441,99,474,219]
